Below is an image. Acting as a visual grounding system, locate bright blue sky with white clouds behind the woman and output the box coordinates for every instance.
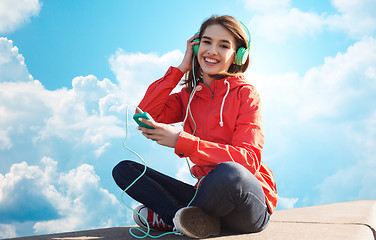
[0,0,376,238]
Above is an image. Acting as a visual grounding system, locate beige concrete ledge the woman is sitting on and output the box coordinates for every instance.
[3,200,376,240]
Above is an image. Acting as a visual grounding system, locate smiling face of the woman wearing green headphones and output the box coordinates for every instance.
[197,24,236,79]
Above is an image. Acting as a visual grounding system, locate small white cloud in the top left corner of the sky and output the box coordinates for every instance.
[0,0,42,33]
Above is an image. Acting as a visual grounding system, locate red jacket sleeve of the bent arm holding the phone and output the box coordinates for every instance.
[175,88,264,174]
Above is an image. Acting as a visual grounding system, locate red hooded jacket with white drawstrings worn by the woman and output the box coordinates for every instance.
[139,67,278,213]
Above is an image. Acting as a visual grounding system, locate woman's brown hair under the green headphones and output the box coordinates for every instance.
[183,15,249,91]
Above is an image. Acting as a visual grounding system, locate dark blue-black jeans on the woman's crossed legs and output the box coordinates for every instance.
[112,161,270,233]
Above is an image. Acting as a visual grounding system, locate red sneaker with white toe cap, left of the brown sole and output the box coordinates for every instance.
[133,205,173,232]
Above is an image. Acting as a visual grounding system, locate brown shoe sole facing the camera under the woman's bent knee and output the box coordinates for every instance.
[174,207,221,238]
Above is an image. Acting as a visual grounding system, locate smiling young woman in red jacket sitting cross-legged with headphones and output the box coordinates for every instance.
[113,16,278,238]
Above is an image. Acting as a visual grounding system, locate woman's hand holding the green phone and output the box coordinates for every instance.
[137,118,180,148]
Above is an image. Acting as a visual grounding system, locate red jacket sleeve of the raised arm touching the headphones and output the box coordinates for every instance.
[138,67,184,123]
